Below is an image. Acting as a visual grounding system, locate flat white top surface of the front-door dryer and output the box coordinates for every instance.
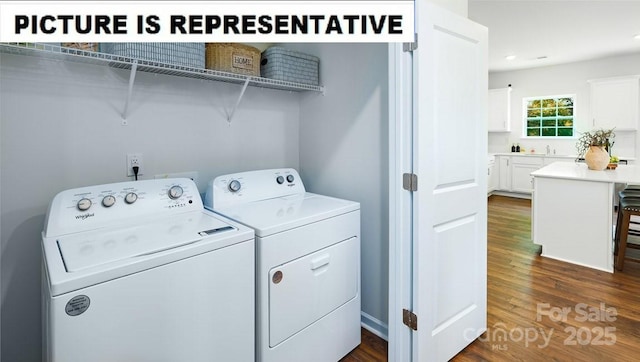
[214,192,360,237]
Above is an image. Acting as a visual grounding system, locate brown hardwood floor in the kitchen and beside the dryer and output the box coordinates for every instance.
[343,196,640,362]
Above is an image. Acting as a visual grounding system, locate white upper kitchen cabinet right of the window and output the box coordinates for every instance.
[589,76,640,131]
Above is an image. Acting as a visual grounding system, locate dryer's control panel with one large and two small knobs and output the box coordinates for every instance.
[204,168,306,210]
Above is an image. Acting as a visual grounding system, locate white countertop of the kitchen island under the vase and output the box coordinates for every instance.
[531,162,640,184]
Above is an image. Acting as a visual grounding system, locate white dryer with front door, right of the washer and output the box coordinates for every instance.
[205,169,360,362]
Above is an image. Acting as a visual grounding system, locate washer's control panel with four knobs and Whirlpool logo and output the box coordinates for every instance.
[44,178,203,237]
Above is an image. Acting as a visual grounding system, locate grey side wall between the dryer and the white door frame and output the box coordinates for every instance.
[292,44,389,338]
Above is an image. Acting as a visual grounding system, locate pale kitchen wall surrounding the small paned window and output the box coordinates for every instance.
[489,53,640,159]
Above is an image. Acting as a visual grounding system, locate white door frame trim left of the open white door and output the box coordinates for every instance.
[388,43,413,362]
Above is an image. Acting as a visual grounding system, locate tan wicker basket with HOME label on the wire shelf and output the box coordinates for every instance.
[205,43,260,77]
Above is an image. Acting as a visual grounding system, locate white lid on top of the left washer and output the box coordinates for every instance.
[57,212,237,273]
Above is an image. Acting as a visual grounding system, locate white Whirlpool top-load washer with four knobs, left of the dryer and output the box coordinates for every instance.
[42,179,255,362]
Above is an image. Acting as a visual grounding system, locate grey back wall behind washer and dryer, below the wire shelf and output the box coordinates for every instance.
[0,54,302,362]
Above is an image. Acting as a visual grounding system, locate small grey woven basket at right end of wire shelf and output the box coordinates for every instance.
[260,47,320,85]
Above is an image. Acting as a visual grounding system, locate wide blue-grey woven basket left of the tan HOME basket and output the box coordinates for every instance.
[100,43,204,68]
